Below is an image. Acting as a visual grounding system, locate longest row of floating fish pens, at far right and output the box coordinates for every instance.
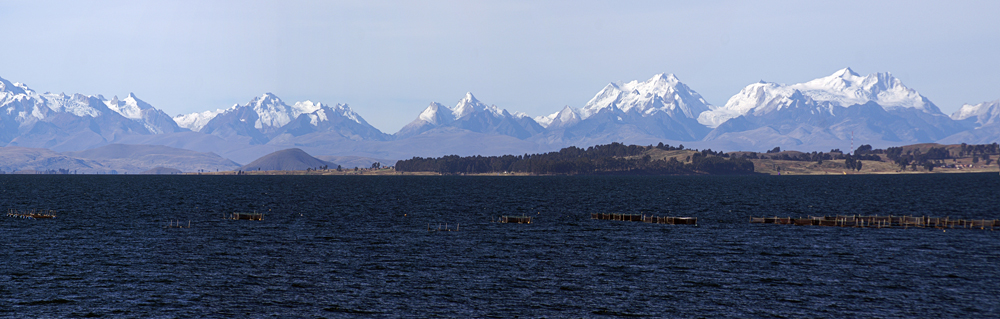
[750,215,1000,230]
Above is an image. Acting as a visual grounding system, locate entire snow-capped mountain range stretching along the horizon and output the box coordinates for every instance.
[0,68,1000,170]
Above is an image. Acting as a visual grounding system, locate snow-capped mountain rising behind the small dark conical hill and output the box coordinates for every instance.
[191,93,387,144]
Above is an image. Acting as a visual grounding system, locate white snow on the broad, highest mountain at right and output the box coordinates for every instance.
[698,68,941,128]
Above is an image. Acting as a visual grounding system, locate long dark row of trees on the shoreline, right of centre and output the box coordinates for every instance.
[396,143,753,175]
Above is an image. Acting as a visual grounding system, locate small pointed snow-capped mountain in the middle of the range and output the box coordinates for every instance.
[396,92,545,139]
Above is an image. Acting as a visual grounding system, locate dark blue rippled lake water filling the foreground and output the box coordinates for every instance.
[0,173,1000,318]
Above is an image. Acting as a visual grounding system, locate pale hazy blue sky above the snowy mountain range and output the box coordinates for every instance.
[0,0,1000,133]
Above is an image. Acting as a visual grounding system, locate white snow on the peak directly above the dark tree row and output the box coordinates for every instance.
[580,73,713,119]
